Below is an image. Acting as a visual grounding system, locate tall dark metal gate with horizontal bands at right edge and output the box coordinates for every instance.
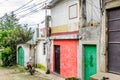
[107,8,120,74]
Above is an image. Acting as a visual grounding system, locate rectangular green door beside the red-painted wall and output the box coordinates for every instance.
[84,45,97,80]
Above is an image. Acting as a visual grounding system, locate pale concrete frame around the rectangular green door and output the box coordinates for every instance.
[77,40,100,80]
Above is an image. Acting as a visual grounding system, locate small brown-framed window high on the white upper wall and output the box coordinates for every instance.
[69,3,78,19]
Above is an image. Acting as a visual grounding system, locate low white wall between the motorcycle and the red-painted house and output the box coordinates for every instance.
[36,41,47,66]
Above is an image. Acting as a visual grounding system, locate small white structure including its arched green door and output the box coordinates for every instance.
[17,44,34,66]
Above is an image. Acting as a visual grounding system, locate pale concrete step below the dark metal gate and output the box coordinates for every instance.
[90,73,120,80]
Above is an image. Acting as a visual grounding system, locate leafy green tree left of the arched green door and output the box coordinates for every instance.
[0,13,33,66]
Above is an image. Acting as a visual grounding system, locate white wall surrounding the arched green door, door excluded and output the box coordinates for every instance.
[17,44,30,66]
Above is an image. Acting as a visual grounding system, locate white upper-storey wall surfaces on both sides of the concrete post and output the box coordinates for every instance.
[51,0,101,26]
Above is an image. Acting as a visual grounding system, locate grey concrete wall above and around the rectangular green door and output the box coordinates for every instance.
[77,26,101,79]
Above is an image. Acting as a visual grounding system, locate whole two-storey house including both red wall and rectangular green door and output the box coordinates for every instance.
[48,0,101,80]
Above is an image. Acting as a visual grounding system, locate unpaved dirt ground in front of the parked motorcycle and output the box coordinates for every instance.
[0,67,51,80]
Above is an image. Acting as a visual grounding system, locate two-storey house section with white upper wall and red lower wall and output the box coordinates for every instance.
[47,0,79,78]
